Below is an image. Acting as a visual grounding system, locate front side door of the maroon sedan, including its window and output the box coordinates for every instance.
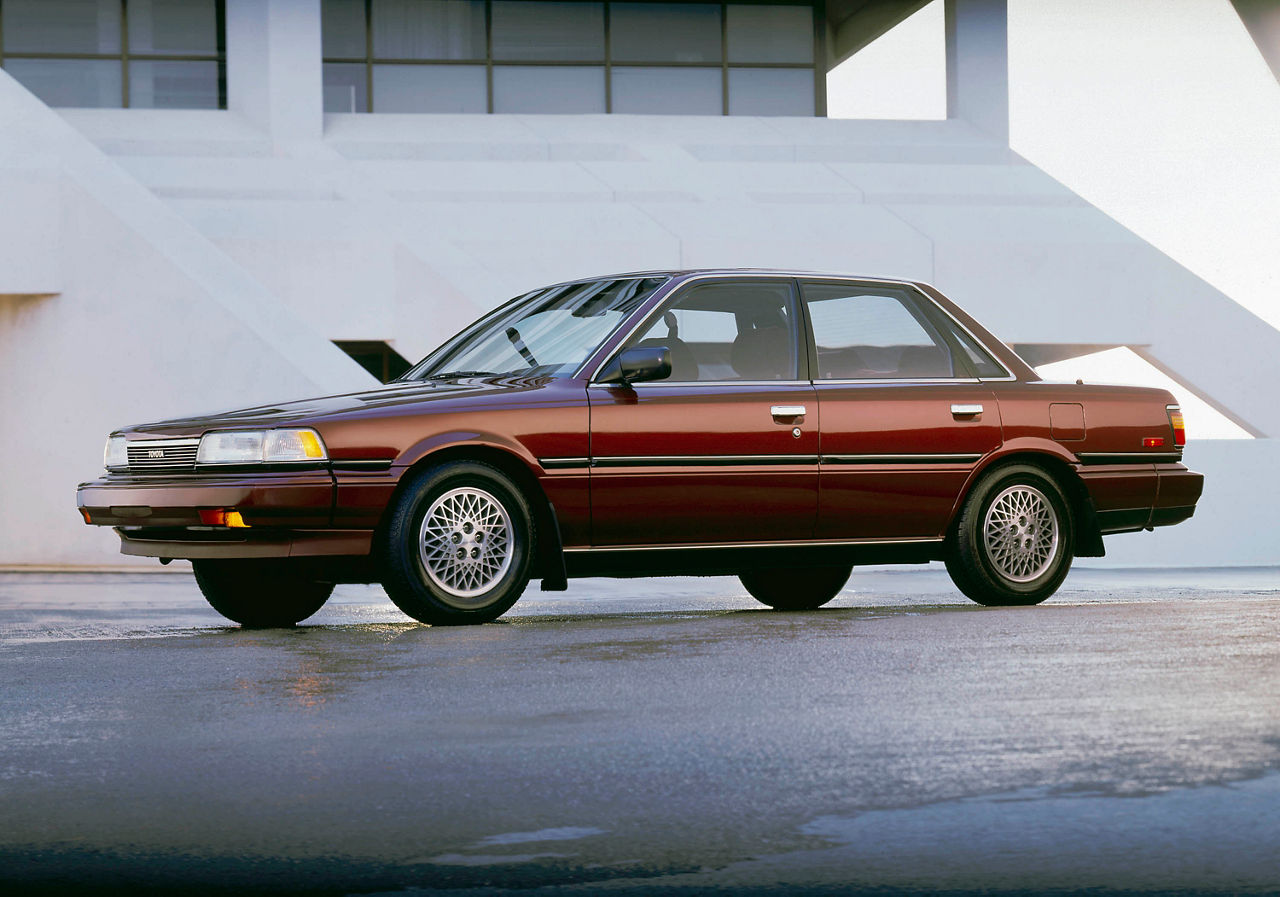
[588,278,818,546]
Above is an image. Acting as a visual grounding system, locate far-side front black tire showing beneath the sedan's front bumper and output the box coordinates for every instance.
[191,558,333,630]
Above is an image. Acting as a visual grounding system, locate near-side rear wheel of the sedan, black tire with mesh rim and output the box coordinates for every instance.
[946,464,1075,608]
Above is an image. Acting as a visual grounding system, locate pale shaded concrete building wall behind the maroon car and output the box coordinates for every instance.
[0,0,1280,564]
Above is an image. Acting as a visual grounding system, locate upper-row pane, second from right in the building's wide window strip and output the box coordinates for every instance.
[609,3,721,63]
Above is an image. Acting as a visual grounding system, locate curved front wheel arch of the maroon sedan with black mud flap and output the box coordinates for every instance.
[374,441,564,580]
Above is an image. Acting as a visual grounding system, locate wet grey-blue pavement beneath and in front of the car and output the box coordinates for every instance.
[0,564,1280,894]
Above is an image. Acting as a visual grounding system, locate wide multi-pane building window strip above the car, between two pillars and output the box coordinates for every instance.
[321,0,826,115]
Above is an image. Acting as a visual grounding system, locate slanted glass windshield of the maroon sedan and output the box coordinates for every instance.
[401,275,668,380]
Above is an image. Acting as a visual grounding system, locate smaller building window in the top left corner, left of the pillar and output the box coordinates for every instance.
[0,0,227,109]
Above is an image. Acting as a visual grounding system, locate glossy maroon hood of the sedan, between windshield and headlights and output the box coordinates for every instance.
[118,377,548,438]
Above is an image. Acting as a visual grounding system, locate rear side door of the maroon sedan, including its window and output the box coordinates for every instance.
[801,280,1002,540]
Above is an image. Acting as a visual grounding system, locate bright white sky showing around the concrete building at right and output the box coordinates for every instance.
[827,0,1280,438]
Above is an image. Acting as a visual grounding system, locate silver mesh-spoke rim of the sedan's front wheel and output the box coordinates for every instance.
[419,486,511,608]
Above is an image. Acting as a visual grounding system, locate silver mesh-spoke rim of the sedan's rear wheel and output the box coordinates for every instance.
[982,485,1057,582]
